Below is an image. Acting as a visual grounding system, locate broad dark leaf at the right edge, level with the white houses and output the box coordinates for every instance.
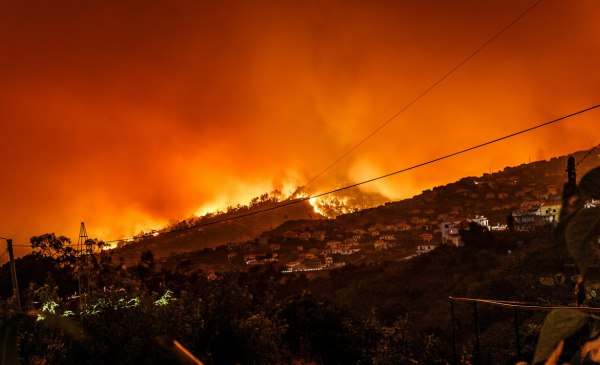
[565,208,600,274]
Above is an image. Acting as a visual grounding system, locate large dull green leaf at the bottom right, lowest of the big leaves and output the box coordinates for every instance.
[533,309,590,364]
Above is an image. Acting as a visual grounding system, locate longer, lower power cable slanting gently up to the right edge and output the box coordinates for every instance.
[104,104,600,243]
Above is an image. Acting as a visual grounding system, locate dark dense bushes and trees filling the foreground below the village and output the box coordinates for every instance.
[0,223,575,364]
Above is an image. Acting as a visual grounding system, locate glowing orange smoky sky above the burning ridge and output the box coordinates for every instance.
[0,0,600,255]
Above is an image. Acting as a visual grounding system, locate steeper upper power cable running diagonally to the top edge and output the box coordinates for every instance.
[299,0,542,190]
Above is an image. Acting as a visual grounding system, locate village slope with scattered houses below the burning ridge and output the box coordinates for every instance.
[157,149,600,277]
